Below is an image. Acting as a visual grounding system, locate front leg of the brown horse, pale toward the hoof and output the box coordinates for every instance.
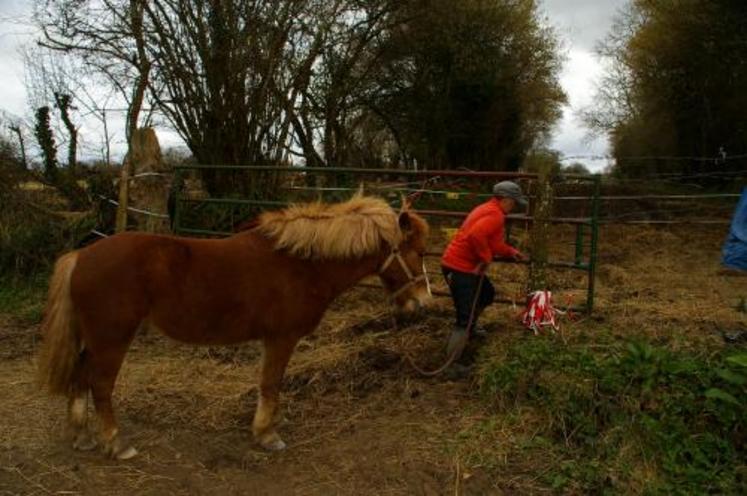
[252,337,298,451]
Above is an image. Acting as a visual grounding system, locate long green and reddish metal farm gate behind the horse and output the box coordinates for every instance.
[172,165,601,313]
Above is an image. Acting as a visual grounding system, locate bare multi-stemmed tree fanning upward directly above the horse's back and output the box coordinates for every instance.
[140,0,350,194]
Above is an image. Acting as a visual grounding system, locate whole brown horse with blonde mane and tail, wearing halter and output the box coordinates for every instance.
[39,195,430,459]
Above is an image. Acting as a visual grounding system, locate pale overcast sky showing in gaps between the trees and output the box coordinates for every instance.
[0,0,627,170]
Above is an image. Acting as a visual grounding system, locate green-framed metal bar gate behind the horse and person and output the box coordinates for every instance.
[172,169,601,313]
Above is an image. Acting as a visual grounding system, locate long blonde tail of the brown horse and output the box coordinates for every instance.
[38,251,81,394]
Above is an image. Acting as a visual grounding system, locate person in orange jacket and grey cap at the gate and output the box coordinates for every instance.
[441,181,527,358]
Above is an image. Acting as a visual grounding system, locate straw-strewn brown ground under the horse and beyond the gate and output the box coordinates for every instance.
[0,227,747,494]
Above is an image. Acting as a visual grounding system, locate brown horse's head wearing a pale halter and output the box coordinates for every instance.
[379,206,432,313]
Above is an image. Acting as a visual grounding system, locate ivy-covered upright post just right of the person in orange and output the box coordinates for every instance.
[528,161,553,292]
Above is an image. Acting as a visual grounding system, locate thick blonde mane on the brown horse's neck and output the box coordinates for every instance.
[257,194,402,260]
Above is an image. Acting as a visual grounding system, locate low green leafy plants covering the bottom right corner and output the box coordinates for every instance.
[481,338,747,494]
